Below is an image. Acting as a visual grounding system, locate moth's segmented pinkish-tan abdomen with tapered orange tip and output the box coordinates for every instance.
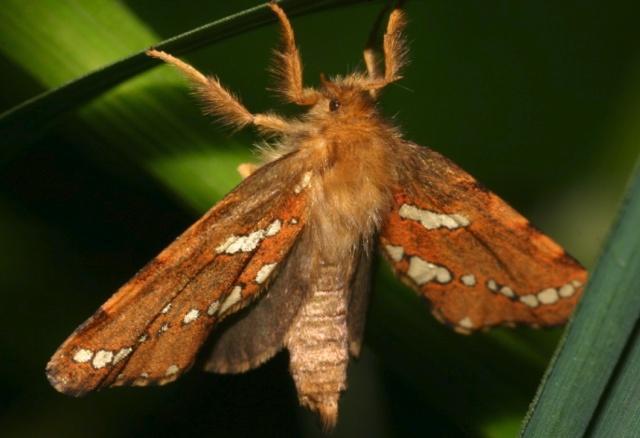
[286,266,349,428]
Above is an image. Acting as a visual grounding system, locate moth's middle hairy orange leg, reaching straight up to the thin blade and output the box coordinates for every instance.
[269,3,318,105]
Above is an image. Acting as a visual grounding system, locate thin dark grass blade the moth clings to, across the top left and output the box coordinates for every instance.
[0,0,362,148]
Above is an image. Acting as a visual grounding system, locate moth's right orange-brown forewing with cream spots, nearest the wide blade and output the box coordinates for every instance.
[380,145,587,332]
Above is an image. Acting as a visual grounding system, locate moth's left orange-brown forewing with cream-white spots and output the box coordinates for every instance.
[47,156,307,395]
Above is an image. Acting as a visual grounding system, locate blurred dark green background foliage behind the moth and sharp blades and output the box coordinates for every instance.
[0,0,640,437]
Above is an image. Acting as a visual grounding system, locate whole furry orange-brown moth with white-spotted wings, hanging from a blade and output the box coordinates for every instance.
[46,3,587,427]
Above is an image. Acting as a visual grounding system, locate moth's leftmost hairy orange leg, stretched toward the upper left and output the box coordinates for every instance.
[147,49,291,133]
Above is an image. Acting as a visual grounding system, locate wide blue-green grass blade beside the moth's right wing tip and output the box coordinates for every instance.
[522,159,640,438]
